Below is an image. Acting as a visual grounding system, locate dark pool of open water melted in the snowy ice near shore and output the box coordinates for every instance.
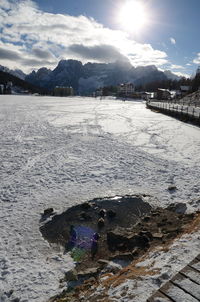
[40,195,151,246]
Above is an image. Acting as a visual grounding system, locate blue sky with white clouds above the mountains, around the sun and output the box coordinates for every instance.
[0,0,200,75]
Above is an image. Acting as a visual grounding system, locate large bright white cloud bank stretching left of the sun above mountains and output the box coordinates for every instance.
[0,0,168,71]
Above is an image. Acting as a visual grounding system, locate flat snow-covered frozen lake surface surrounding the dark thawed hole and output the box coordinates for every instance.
[0,96,200,302]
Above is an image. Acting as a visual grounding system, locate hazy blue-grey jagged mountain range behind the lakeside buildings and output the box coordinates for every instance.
[0,59,180,95]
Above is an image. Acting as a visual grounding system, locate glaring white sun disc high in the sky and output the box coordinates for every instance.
[119,0,147,32]
